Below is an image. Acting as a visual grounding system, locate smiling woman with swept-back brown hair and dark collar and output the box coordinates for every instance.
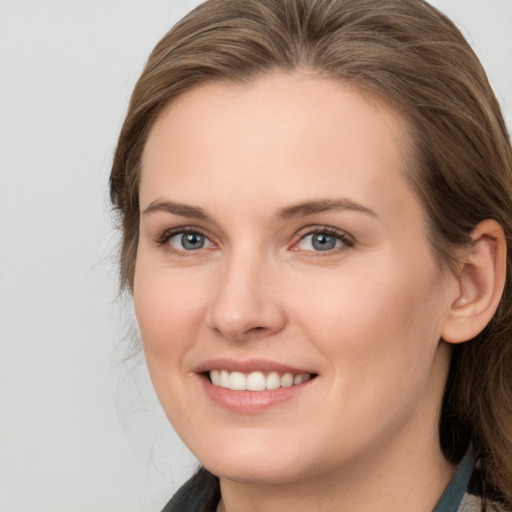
[111,0,512,512]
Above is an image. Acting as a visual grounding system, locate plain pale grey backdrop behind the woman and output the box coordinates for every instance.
[0,0,512,512]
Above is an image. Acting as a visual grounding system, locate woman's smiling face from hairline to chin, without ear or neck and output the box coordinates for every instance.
[134,73,457,482]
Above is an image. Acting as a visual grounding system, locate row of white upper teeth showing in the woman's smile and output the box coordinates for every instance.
[210,370,311,391]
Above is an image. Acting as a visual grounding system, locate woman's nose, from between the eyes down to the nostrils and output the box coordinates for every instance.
[208,248,286,341]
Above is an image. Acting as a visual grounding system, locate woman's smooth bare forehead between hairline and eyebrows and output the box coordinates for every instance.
[140,73,412,222]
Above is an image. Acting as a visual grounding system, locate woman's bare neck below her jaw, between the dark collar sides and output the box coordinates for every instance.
[220,428,455,512]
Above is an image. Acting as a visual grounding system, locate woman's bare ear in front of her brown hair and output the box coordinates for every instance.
[442,219,507,343]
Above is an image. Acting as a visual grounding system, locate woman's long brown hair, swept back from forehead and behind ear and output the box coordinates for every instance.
[110,0,512,504]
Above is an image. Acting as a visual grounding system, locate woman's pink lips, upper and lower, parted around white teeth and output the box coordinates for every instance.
[195,358,317,414]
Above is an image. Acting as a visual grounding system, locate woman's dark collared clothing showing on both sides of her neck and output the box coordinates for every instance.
[162,449,512,512]
